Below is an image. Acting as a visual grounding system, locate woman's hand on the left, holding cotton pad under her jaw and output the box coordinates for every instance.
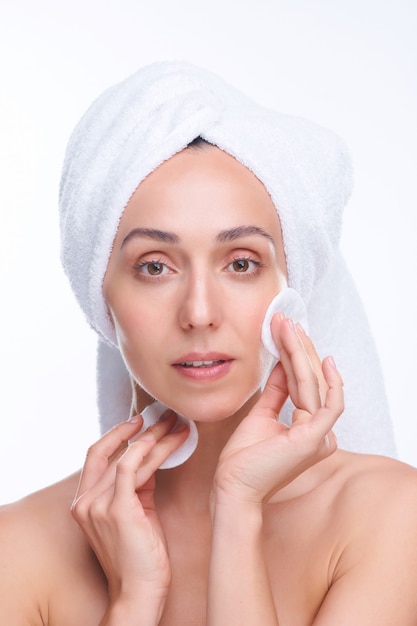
[72,411,188,623]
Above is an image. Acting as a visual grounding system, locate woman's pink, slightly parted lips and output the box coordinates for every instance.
[172,352,234,382]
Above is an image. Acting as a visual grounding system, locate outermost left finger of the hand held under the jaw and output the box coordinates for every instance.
[76,416,143,497]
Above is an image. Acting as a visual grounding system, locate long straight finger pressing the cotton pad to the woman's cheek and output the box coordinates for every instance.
[274,318,321,414]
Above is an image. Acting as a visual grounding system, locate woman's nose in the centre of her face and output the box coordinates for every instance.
[179,271,222,330]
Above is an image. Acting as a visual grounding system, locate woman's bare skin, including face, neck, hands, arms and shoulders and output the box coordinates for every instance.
[0,144,417,626]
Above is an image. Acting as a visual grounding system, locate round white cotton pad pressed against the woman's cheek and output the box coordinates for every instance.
[262,287,308,360]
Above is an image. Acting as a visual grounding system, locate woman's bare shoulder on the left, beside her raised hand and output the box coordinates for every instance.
[0,475,104,626]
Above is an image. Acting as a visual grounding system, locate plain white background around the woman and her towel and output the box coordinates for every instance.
[0,0,417,502]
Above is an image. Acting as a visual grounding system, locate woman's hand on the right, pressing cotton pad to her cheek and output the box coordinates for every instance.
[213,314,344,503]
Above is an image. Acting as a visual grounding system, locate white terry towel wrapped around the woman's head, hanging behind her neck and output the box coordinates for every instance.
[60,62,395,456]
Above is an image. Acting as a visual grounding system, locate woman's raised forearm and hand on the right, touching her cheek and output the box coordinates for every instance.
[208,318,343,626]
